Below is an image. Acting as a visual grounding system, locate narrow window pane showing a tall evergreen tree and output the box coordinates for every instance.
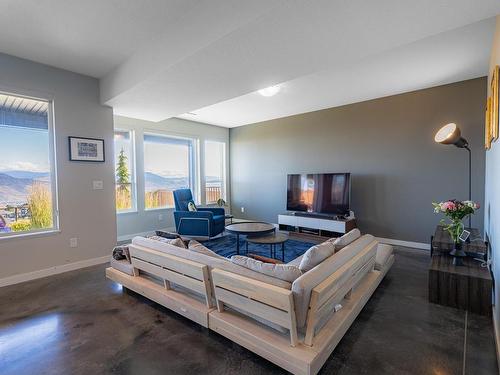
[115,130,136,212]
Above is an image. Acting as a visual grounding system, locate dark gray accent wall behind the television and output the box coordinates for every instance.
[230,78,486,243]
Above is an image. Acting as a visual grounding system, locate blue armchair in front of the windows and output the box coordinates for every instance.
[174,189,225,238]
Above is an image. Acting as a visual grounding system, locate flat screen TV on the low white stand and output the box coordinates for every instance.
[286,173,351,215]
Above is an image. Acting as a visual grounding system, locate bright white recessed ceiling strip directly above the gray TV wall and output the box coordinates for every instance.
[178,18,495,128]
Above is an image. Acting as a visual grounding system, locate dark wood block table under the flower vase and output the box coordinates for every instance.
[429,226,492,316]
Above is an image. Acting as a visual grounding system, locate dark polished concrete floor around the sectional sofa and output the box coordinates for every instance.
[0,249,498,375]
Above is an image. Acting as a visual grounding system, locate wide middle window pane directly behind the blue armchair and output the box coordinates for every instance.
[144,134,195,209]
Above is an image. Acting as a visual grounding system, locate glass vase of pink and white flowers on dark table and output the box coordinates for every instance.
[432,199,479,266]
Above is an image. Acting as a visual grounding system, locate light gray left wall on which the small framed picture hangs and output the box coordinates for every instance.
[0,54,116,285]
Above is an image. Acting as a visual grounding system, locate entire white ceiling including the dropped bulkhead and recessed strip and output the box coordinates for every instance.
[0,0,500,127]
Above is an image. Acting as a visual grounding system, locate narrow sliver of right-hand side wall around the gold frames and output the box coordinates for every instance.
[484,16,500,362]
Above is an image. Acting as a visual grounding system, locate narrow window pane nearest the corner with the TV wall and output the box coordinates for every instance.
[205,141,226,204]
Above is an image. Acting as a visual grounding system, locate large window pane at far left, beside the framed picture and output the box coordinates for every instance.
[0,93,58,236]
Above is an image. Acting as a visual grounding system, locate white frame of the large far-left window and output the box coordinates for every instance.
[0,87,61,241]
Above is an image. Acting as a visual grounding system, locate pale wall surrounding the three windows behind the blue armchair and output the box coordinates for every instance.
[115,116,230,240]
